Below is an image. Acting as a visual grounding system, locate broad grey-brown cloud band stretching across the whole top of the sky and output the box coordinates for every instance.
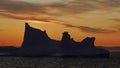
[0,0,120,15]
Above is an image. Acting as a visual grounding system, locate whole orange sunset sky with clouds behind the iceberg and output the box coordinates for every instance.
[0,0,120,47]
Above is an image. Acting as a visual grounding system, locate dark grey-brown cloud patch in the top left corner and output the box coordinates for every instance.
[0,0,46,13]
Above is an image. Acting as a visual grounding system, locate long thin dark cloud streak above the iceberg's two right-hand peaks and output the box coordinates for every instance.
[63,24,117,34]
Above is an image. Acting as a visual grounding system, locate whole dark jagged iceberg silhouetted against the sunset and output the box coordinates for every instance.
[0,23,110,57]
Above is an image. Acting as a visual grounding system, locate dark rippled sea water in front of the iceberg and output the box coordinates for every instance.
[0,52,120,68]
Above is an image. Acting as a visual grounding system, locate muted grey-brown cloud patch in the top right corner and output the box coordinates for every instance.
[53,0,120,13]
